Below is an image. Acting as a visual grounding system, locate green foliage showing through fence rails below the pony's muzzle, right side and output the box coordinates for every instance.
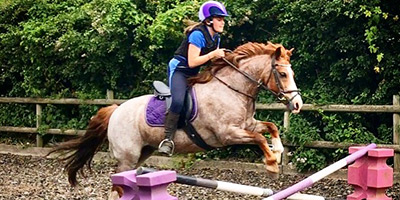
[285,111,382,171]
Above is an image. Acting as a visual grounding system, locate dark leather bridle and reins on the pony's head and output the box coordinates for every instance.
[211,50,301,105]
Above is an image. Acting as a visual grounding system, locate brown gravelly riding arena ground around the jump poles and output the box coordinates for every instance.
[0,154,400,200]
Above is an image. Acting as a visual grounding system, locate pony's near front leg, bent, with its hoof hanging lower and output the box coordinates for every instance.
[220,127,279,173]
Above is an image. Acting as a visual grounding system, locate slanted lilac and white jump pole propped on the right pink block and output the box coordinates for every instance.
[263,144,376,200]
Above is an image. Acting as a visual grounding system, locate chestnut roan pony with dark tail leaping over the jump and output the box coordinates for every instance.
[47,42,303,186]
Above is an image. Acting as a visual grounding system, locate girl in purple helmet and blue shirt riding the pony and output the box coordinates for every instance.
[158,1,229,156]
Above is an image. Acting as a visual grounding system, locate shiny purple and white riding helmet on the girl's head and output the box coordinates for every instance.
[199,1,229,21]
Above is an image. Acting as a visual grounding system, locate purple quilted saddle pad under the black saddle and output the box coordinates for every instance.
[145,88,197,127]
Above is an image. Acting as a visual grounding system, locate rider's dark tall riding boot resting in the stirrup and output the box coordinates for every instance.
[158,111,179,156]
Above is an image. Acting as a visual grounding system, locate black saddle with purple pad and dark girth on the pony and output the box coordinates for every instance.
[146,81,214,150]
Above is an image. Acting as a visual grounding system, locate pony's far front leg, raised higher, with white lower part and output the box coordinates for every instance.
[248,119,284,163]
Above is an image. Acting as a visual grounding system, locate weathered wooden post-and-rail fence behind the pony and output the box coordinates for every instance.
[0,90,400,171]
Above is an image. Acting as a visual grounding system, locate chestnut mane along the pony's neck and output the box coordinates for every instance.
[188,42,284,85]
